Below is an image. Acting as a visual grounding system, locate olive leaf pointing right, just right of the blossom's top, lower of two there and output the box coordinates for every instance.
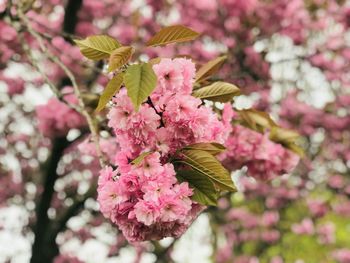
[192,81,240,102]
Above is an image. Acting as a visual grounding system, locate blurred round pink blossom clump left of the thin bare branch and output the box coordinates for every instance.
[36,88,86,138]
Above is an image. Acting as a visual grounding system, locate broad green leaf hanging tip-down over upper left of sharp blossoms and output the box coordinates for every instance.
[124,63,157,111]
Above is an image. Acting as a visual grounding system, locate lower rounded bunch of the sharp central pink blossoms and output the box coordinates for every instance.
[98,157,201,242]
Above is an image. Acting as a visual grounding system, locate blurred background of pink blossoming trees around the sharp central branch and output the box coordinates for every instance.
[0,0,350,263]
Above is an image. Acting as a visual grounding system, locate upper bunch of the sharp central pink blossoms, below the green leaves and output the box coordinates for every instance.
[108,58,227,158]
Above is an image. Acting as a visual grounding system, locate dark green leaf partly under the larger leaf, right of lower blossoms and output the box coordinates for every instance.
[176,170,218,206]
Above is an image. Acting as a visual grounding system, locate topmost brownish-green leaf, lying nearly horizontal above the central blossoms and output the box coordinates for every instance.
[147,25,199,47]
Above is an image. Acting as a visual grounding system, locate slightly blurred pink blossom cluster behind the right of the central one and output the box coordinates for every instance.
[221,125,299,180]
